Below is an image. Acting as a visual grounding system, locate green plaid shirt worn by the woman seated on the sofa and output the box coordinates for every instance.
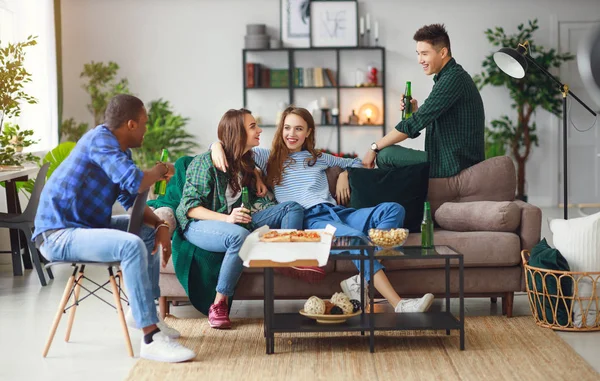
[176,151,276,231]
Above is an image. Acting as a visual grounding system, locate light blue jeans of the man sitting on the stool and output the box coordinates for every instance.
[40,215,160,328]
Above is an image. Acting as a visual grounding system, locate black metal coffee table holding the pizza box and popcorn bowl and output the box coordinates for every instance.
[264,237,465,354]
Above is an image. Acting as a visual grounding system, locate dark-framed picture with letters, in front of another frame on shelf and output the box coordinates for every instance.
[310,0,358,48]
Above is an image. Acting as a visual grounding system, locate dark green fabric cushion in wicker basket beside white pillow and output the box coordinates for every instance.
[527,238,573,326]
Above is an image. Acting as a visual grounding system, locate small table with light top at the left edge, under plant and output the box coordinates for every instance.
[0,164,40,275]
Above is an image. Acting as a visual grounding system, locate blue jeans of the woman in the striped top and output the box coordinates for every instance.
[304,202,405,282]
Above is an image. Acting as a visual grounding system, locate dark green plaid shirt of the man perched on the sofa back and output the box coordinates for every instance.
[396,58,485,177]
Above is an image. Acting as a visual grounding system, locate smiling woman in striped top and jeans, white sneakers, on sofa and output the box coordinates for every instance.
[212,107,433,312]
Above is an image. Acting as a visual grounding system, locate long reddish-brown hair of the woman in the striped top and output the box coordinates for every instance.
[267,106,321,187]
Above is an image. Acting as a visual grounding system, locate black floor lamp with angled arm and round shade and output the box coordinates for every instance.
[494,41,596,220]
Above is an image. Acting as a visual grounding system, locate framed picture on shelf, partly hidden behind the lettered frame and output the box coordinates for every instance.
[280,0,310,48]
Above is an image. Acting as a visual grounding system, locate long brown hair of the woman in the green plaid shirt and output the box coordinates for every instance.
[217,108,255,194]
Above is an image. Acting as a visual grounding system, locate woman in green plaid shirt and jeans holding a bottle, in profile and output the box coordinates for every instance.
[177,109,303,329]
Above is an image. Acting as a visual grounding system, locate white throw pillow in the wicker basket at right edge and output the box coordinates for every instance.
[550,213,600,328]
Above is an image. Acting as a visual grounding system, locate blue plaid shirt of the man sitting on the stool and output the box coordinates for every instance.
[33,125,144,239]
